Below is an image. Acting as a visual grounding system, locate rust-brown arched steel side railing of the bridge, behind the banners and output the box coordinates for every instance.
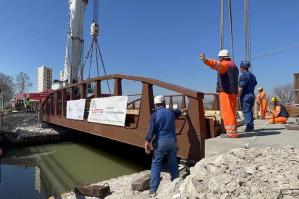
[41,74,207,161]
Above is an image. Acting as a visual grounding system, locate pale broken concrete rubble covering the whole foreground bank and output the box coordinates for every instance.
[62,147,299,199]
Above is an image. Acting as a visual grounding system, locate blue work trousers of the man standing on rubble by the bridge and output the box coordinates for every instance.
[150,138,179,192]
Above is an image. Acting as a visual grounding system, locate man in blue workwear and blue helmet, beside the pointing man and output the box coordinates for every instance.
[239,61,257,132]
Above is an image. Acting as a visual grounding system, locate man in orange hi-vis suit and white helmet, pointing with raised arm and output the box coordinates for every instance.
[199,49,239,138]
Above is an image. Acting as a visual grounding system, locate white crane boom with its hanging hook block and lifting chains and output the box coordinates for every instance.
[59,0,111,93]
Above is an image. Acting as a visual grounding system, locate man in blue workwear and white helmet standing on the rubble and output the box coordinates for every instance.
[144,95,187,196]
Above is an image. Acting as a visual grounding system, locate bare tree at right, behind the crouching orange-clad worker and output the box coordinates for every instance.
[273,84,294,103]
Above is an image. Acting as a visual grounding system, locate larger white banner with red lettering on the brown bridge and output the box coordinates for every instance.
[87,96,128,126]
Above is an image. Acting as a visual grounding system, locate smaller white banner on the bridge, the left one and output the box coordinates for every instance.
[66,99,86,120]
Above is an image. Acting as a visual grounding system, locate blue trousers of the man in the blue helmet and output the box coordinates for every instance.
[241,93,255,129]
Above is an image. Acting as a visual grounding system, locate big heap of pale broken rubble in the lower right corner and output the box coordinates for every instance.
[177,147,299,199]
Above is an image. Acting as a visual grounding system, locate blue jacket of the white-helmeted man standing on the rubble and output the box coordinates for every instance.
[145,107,181,142]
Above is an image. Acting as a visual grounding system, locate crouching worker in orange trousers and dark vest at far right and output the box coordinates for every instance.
[267,97,289,124]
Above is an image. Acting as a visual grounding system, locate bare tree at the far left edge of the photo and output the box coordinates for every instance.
[0,73,15,108]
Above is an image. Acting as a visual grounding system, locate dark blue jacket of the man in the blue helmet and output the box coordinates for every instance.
[239,71,257,98]
